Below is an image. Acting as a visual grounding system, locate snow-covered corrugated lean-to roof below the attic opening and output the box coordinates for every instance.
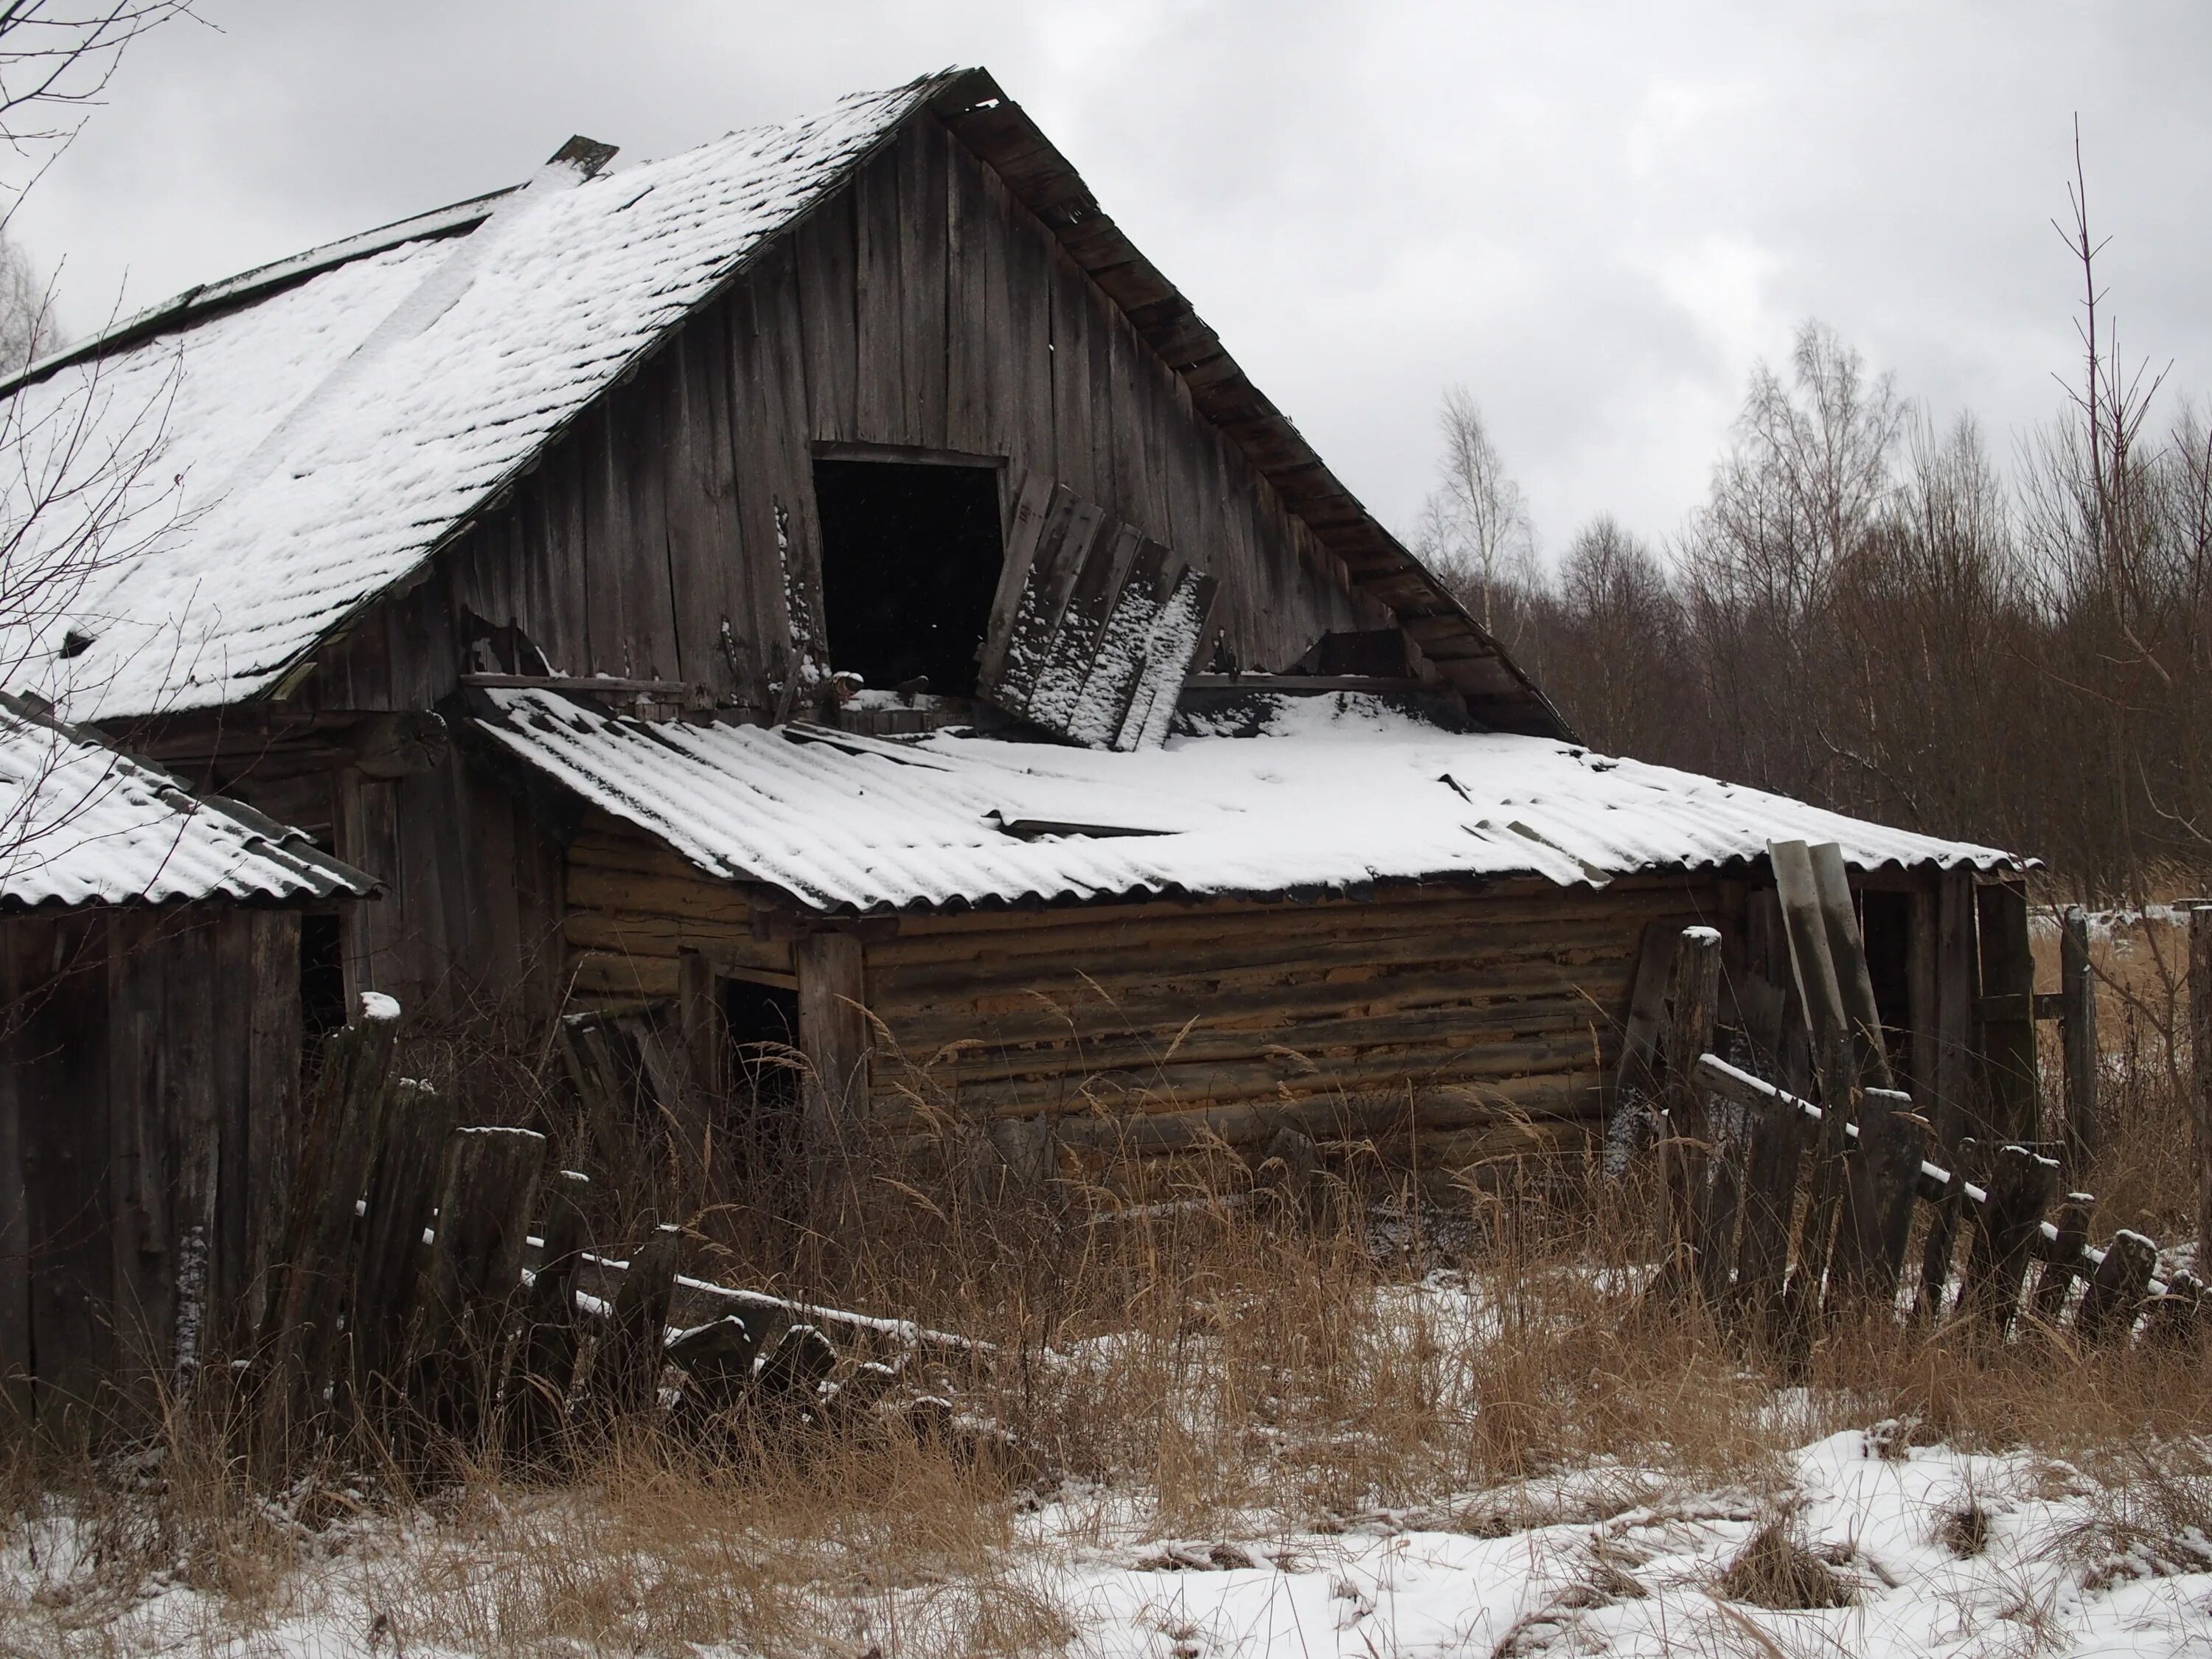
[478,690,2017,911]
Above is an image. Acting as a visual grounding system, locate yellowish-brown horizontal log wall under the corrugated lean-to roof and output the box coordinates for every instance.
[553,836,1719,1159]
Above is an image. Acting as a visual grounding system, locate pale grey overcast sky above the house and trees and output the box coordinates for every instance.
[13,0,2212,553]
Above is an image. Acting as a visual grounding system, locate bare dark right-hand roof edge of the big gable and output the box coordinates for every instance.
[929,69,1573,739]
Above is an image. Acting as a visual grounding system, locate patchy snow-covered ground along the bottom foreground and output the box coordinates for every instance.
[17,1425,2212,1659]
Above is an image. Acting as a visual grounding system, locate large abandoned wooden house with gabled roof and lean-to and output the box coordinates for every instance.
[9,71,2033,1194]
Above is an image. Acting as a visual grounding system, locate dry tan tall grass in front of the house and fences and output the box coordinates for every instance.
[0,1133,2212,1655]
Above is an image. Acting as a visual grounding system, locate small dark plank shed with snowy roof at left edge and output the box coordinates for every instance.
[0,697,374,1405]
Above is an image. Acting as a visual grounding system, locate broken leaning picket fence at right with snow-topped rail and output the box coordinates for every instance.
[1657,843,2208,1345]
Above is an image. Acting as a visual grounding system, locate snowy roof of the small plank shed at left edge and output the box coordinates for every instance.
[0,697,376,909]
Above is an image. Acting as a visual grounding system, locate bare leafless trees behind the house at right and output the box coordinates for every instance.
[1416,319,2212,898]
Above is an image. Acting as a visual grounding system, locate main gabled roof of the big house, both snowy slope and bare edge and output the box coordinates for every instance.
[0,71,1564,732]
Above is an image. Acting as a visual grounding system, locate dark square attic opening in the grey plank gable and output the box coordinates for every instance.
[814,460,1004,697]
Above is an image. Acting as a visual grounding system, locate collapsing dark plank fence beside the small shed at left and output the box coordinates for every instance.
[246,1000,942,1464]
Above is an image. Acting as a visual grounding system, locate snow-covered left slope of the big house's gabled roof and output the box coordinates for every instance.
[0,80,936,719]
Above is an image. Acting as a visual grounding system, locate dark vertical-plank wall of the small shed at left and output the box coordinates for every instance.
[0,907,301,1433]
